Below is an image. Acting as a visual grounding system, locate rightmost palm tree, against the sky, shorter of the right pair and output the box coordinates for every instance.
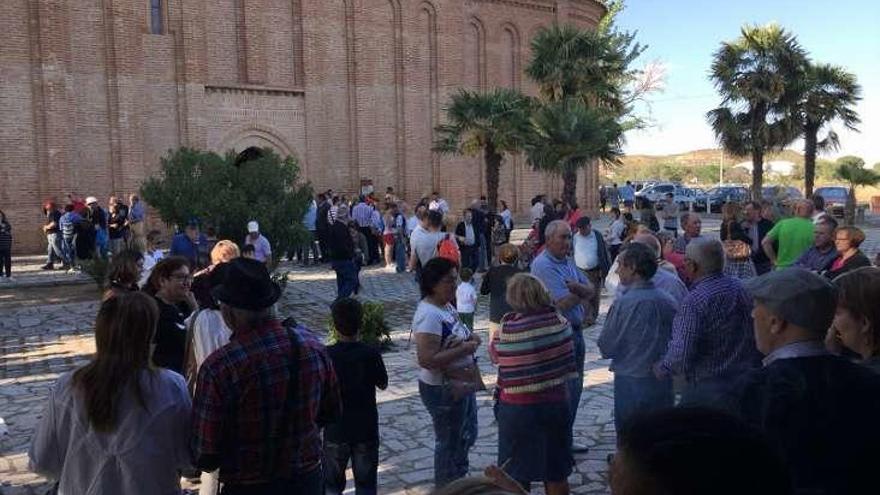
[797,63,862,198]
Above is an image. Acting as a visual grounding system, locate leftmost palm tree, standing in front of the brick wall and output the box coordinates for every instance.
[434,88,532,211]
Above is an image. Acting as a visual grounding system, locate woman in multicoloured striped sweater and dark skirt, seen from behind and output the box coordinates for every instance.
[490,273,577,495]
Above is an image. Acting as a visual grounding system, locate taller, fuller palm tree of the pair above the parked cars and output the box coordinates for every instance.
[707,24,807,199]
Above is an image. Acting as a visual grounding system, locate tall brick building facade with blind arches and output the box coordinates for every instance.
[0,0,604,252]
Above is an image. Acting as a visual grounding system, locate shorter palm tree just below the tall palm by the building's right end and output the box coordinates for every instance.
[526,99,623,204]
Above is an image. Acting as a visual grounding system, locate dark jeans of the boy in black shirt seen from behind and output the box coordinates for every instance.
[324,441,379,495]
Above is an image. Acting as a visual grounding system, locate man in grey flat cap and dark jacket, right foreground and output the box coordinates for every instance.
[735,268,880,494]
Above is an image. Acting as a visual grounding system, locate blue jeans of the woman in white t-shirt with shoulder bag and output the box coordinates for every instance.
[419,381,477,488]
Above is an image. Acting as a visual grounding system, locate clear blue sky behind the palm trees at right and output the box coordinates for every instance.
[618,0,880,165]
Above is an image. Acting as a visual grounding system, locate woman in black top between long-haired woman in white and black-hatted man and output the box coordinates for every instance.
[145,256,198,374]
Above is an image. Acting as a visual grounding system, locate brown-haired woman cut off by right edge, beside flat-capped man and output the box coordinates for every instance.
[827,267,880,373]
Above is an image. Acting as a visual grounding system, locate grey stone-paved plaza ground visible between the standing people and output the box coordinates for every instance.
[0,220,880,495]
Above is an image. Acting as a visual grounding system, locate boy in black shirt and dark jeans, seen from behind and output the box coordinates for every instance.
[324,297,388,495]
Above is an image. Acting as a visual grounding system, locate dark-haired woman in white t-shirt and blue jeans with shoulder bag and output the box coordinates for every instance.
[412,258,481,487]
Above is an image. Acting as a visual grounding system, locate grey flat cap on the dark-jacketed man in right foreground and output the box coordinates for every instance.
[743,268,837,334]
